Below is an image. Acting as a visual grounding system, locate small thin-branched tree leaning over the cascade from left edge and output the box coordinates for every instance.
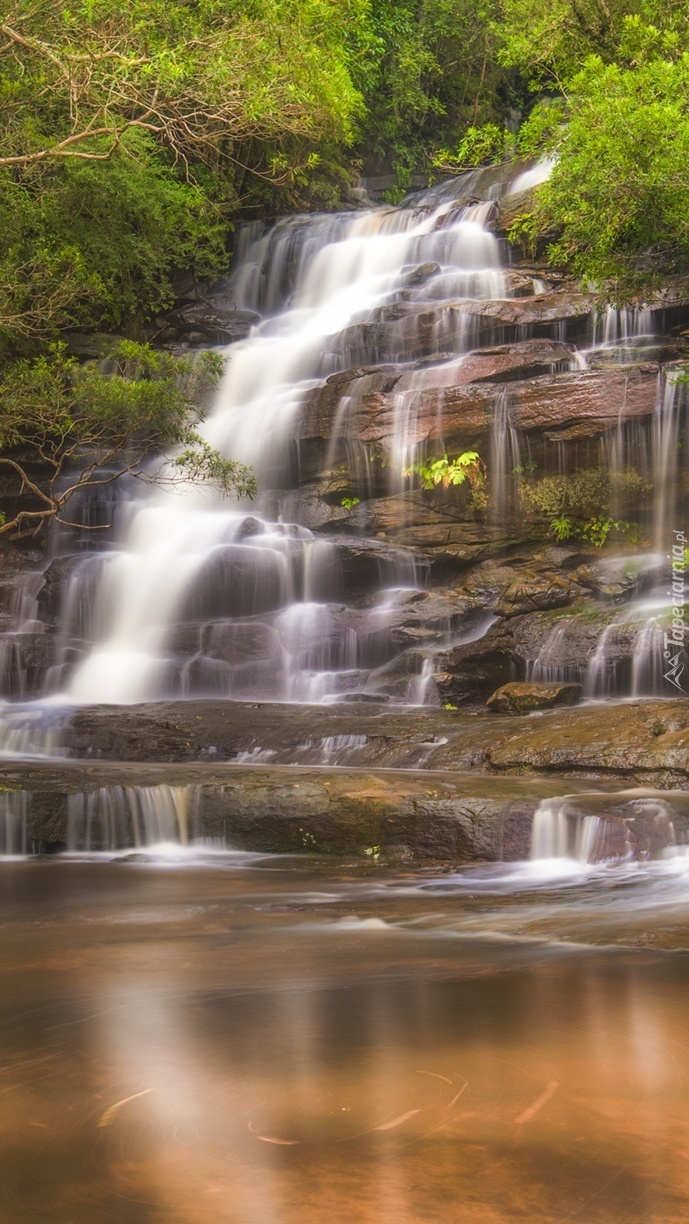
[0,341,256,536]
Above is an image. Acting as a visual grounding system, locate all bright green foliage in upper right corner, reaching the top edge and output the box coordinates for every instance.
[502,0,689,291]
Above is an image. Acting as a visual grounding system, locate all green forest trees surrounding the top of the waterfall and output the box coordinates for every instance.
[0,0,689,533]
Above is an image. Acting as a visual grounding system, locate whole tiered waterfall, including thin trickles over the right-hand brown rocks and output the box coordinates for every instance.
[0,164,688,714]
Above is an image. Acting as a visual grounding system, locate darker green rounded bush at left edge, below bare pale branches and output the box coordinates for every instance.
[0,131,228,350]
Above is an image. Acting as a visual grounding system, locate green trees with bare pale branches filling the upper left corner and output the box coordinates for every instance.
[0,0,368,355]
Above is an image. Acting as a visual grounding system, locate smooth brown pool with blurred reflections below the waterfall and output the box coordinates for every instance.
[0,858,689,1224]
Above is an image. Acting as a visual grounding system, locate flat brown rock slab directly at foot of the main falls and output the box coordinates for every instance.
[21,690,689,787]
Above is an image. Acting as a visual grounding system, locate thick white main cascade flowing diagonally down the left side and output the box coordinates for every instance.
[54,195,505,703]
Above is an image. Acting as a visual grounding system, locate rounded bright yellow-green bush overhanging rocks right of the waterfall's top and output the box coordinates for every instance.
[541,55,689,291]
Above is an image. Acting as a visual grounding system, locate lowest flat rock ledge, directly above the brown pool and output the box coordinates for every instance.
[0,761,646,863]
